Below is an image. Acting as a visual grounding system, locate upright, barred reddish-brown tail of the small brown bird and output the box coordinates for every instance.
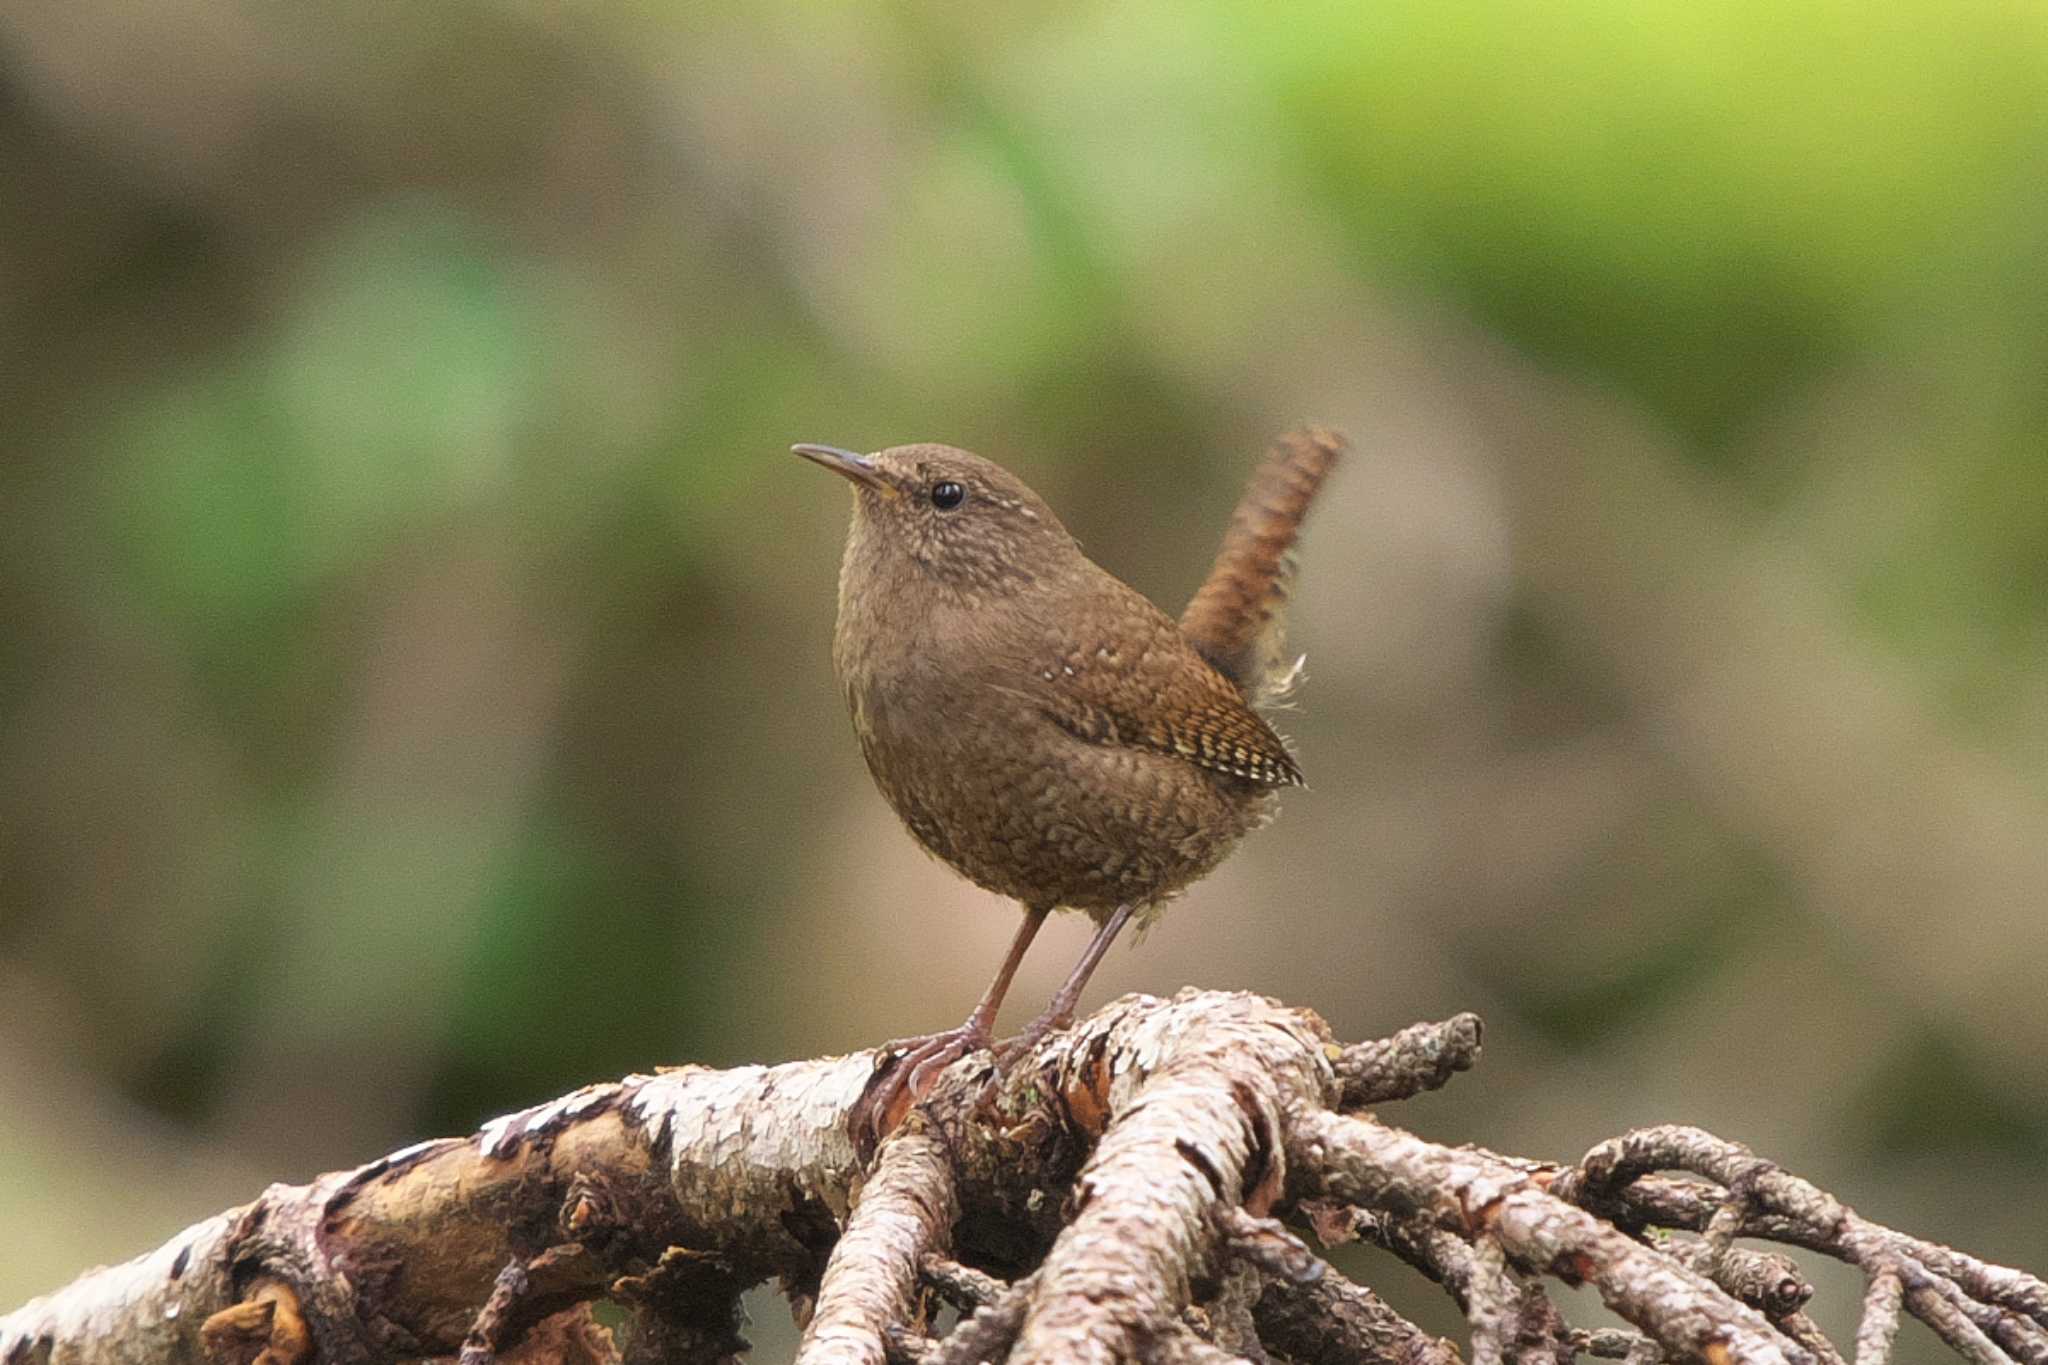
[1180,426,1346,702]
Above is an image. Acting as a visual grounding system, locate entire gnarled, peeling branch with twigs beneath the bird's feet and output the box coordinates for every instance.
[0,990,2048,1365]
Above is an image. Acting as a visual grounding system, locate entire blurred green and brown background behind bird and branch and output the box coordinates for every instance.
[0,0,2048,1358]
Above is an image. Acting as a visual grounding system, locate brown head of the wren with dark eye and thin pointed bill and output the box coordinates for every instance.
[791,442,1081,596]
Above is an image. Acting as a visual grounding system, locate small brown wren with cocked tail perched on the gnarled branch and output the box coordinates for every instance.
[793,430,1343,1136]
